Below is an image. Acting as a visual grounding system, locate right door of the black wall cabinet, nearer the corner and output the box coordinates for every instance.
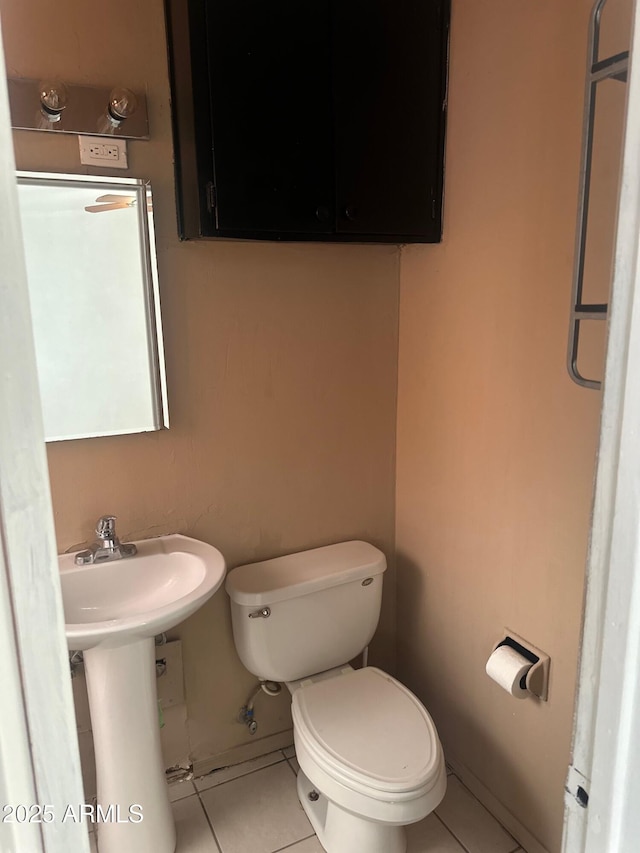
[333,0,448,241]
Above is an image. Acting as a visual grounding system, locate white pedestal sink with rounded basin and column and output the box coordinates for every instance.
[59,534,225,853]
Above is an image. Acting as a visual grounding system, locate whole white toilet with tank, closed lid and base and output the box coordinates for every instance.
[226,541,447,853]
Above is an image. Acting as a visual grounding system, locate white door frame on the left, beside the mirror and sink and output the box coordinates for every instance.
[0,13,89,853]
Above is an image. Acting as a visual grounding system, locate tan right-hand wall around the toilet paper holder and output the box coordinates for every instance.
[396,0,600,853]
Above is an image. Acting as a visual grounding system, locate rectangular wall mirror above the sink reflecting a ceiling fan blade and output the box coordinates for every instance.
[18,172,168,441]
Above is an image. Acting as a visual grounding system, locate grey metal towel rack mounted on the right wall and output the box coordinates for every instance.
[567,0,629,389]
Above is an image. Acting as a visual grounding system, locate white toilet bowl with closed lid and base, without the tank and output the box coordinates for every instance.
[291,667,446,853]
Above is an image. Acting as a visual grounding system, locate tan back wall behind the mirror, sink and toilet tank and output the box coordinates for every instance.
[0,0,399,760]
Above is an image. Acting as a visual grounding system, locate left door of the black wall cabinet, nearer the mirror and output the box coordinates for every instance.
[206,0,334,237]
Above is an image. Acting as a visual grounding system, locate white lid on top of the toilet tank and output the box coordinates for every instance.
[225,540,387,607]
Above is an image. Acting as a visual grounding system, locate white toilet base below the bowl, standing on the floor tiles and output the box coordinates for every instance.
[298,770,407,853]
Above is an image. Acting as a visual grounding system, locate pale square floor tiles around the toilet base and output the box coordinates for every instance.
[91,747,525,853]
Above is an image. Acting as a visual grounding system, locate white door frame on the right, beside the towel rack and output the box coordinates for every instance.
[563,2,640,853]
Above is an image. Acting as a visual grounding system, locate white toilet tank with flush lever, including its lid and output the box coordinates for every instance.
[225,541,387,681]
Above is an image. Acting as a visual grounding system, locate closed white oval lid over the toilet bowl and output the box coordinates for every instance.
[292,667,440,793]
